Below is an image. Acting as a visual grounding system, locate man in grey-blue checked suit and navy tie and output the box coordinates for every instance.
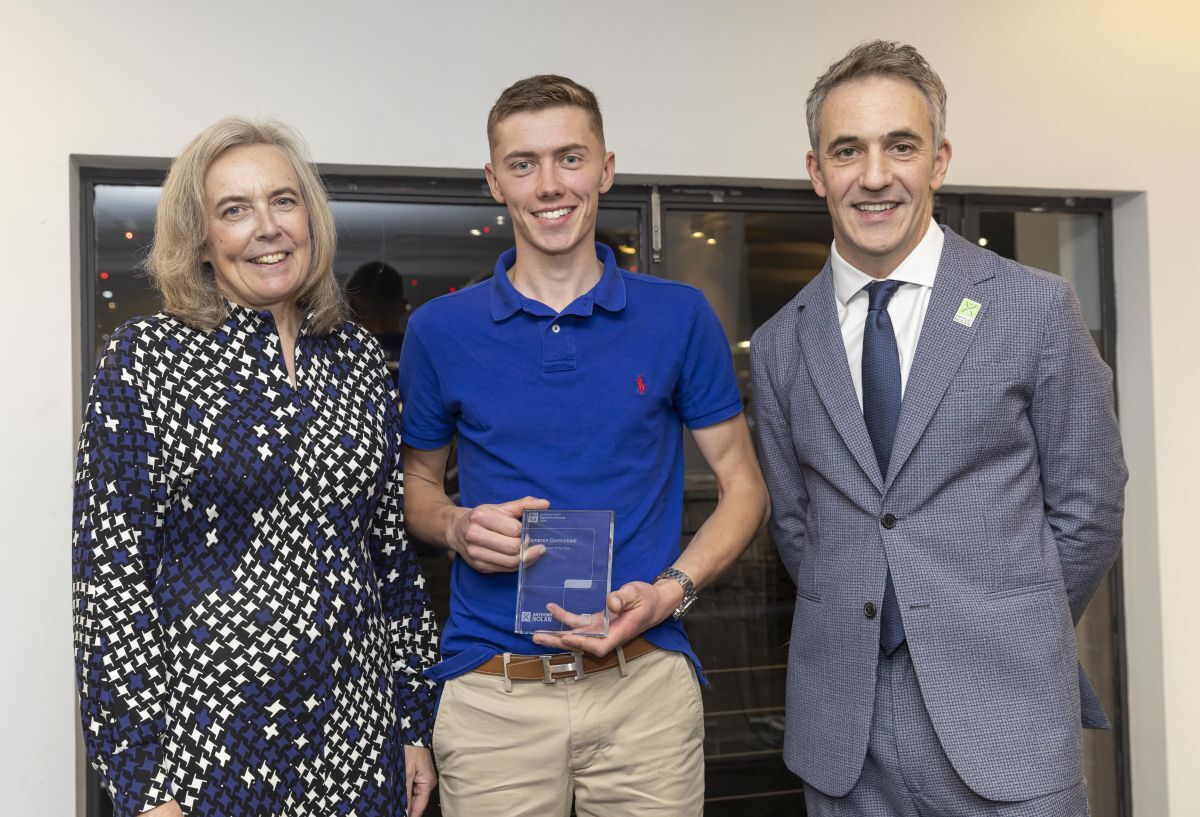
[751,42,1126,817]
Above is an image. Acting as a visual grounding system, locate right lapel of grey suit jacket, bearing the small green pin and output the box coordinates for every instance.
[888,229,995,486]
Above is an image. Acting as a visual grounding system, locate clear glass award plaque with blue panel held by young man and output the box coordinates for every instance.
[515,510,613,638]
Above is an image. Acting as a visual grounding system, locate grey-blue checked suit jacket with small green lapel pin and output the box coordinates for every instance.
[750,228,1126,800]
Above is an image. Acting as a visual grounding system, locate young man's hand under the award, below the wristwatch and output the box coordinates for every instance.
[533,573,683,655]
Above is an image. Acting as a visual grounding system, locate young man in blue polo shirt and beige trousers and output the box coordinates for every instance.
[400,76,767,817]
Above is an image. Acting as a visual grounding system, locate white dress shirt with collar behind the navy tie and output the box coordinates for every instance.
[829,220,946,407]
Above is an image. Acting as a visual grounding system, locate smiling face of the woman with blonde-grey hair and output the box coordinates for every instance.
[200,145,312,319]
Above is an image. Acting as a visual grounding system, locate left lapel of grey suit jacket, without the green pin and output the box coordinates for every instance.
[796,260,883,491]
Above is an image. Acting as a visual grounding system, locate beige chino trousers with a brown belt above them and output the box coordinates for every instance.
[433,650,704,817]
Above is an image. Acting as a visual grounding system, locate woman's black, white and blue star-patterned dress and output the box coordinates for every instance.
[73,305,437,817]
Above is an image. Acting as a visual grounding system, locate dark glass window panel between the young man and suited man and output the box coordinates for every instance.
[664,210,833,817]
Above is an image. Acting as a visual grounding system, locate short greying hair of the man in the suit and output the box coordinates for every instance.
[805,40,946,155]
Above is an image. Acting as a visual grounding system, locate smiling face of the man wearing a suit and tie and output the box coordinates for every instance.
[806,76,950,278]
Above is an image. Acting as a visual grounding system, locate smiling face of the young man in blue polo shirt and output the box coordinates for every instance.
[484,106,616,263]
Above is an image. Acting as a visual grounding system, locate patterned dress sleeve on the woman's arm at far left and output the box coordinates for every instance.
[72,325,173,815]
